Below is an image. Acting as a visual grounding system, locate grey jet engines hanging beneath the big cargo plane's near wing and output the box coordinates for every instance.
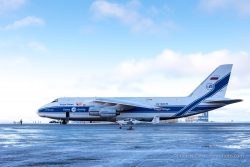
[89,107,117,118]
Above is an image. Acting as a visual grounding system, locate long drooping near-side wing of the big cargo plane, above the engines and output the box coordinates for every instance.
[94,98,159,110]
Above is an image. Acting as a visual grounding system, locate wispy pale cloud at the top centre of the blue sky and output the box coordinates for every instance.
[91,0,175,33]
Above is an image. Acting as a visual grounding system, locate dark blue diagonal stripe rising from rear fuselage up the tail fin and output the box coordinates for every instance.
[174,73,230,117]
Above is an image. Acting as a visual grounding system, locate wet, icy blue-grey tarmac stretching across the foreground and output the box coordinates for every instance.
[0,123,250,167]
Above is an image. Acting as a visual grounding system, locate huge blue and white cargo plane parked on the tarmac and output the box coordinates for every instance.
[38,64,241,121]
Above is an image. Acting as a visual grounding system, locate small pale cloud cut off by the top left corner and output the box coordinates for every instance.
[0,0,26,15]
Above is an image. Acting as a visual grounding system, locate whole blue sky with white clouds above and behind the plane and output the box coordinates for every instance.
[0,0,250,122]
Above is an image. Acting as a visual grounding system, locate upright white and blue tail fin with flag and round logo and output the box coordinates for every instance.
[189,64,233,98]
